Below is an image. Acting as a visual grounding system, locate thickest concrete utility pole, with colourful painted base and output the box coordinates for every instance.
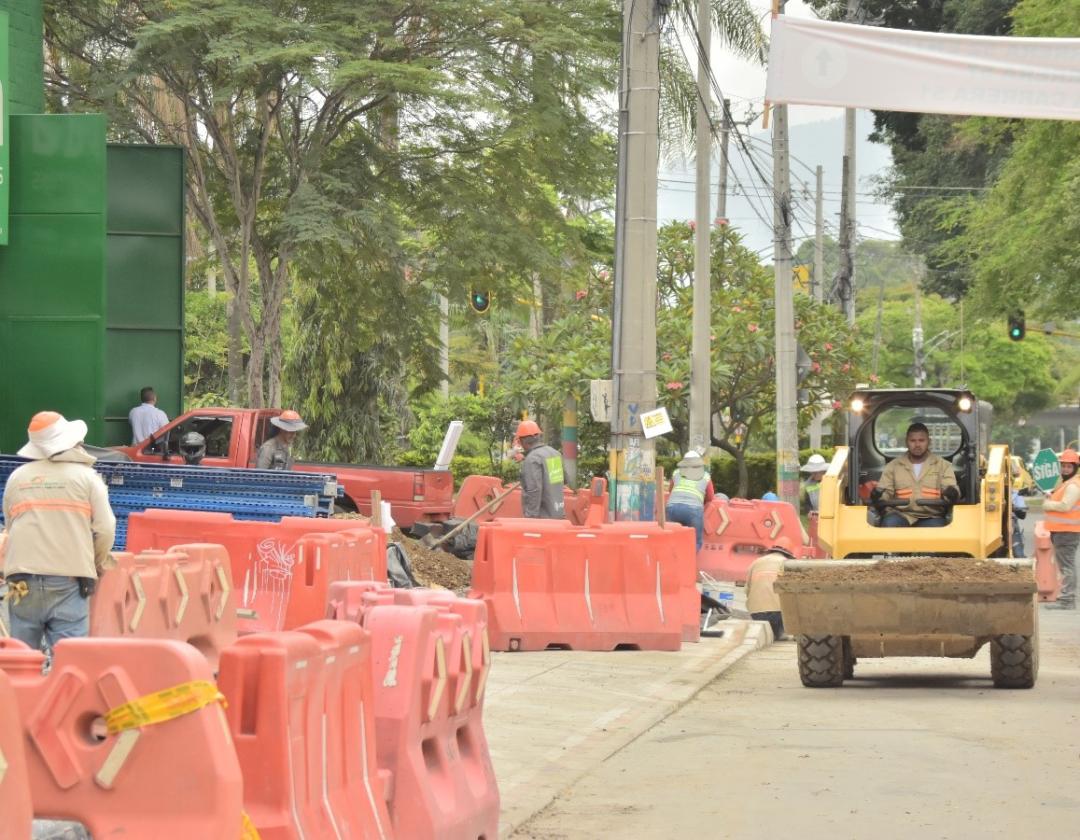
[610,0,661,519]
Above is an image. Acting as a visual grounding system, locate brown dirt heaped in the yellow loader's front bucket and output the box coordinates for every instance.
[783,557,1032,584]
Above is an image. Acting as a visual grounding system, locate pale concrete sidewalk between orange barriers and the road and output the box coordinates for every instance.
[484,620,772,837]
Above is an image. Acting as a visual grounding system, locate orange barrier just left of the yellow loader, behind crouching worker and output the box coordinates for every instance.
[698,499,802,583]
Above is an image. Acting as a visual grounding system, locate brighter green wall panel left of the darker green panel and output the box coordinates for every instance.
[0,114,106,452]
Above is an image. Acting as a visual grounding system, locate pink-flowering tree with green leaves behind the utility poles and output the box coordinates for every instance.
[503,222,858,494]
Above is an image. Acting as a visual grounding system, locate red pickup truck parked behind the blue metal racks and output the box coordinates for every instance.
[117,408,454,528]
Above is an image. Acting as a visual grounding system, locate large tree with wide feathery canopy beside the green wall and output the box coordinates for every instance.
[46,0,618,405]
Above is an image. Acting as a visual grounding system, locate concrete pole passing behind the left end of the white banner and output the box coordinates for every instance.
[772,0,799,510]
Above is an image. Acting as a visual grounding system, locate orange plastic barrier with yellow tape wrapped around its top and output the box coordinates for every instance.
[0,638,243,840]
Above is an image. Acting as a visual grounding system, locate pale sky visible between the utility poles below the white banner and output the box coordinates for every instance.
[659,0,900,254]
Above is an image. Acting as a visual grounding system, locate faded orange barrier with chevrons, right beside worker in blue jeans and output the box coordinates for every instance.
[90,544,237,670]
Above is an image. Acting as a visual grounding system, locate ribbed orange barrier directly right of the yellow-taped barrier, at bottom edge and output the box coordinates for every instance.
[218,621,392,840]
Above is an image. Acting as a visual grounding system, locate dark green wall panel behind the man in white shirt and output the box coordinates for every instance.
[105,146,184,444]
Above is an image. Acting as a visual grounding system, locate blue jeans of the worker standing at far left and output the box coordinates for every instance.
[9,574,90,650]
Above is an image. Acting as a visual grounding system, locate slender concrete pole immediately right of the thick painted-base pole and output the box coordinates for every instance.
[690,0,713,455]
